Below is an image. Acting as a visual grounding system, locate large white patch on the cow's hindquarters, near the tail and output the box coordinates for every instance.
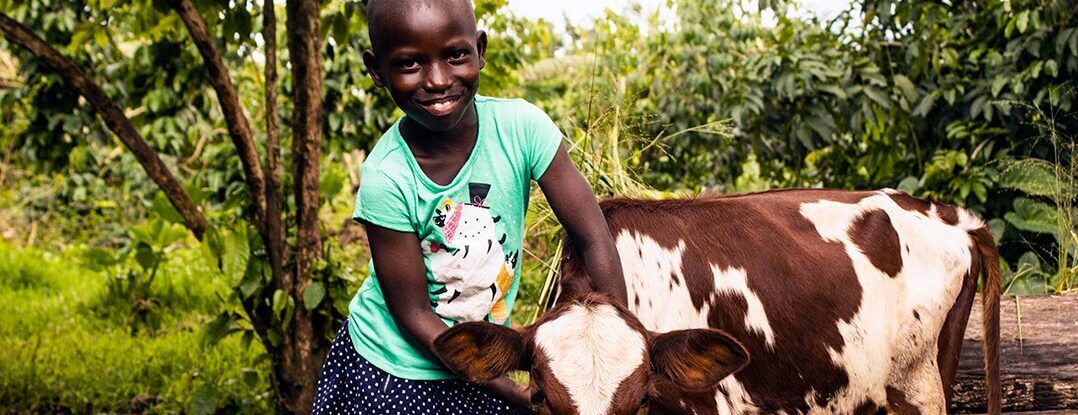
[801,193,975,414]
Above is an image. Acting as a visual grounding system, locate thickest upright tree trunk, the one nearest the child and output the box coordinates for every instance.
[275,0,329,414]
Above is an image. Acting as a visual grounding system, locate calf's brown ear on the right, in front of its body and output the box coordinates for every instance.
[651,329,749,390]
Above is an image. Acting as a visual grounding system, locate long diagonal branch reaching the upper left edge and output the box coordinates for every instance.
[0,13,209,240]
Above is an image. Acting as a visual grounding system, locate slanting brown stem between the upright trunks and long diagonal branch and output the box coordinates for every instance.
[169,0,268,236]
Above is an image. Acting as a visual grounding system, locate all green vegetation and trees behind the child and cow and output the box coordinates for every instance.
[0,0,1078,413]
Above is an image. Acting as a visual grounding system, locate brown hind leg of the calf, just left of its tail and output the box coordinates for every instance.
[936,254,981,407]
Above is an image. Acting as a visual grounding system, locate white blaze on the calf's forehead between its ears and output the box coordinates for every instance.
[535,304,645,415]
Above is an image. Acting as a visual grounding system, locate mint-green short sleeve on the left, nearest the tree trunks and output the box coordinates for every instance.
[351,166,416,232]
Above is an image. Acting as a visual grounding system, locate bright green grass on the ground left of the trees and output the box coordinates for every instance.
[0,243,272,414]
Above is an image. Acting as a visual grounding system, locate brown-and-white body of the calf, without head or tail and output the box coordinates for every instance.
[563,190,983,414]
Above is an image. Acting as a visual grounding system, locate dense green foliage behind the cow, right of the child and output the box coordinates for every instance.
[523,1,1078,293]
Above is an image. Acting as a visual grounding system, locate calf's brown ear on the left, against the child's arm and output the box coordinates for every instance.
[434,321,524,383]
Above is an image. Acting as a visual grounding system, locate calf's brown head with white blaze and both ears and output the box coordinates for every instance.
[434,294,748,415]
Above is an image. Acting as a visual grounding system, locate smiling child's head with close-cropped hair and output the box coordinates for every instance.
[363,5,486,132]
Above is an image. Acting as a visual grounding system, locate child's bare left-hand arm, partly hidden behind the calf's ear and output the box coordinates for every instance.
[365,223,528,410]
